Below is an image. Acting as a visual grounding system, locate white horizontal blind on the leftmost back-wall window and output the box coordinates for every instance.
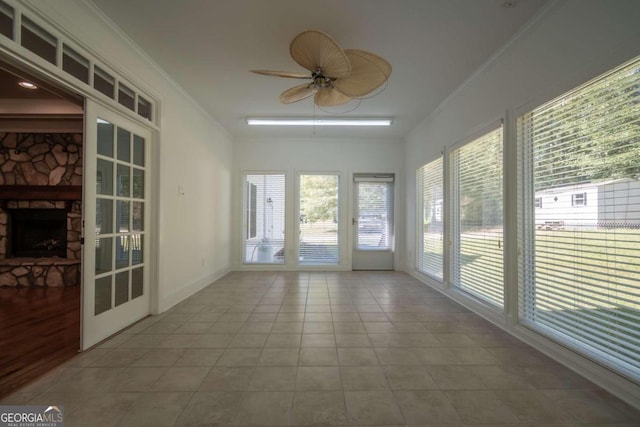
[244,174,285,264]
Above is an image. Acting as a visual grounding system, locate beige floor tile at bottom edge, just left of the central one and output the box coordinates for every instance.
[233,392,293,426]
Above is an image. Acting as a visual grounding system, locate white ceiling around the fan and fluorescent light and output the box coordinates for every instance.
[87,0,545,139]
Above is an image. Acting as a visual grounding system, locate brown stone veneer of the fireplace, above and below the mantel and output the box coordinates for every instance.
[0,133,82,287]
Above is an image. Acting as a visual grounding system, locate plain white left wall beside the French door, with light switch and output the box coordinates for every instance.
[16,0,238,311]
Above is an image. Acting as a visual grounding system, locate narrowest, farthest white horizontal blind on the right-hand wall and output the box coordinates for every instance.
[417,157,444,280]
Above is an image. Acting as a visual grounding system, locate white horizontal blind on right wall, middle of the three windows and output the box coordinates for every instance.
[450,127,504,309]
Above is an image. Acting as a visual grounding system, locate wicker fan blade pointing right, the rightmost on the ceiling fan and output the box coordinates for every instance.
[333,49,391,98]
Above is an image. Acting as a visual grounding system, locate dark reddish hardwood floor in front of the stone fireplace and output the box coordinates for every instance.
[0,286,80,397]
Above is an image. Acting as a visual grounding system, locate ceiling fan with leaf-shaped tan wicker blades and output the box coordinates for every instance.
[251,30,391,107]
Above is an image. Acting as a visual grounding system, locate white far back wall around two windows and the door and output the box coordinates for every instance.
[232,138,404,270]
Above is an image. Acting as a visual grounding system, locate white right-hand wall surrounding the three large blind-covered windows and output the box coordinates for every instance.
[404,0,640,405]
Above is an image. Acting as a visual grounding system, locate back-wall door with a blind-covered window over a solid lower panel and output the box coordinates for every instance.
[351,174,394,270]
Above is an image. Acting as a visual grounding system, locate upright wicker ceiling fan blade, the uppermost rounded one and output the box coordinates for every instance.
[289,30,351,78]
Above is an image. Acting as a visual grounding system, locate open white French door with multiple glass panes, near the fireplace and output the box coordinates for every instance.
[82,100,151,349]
